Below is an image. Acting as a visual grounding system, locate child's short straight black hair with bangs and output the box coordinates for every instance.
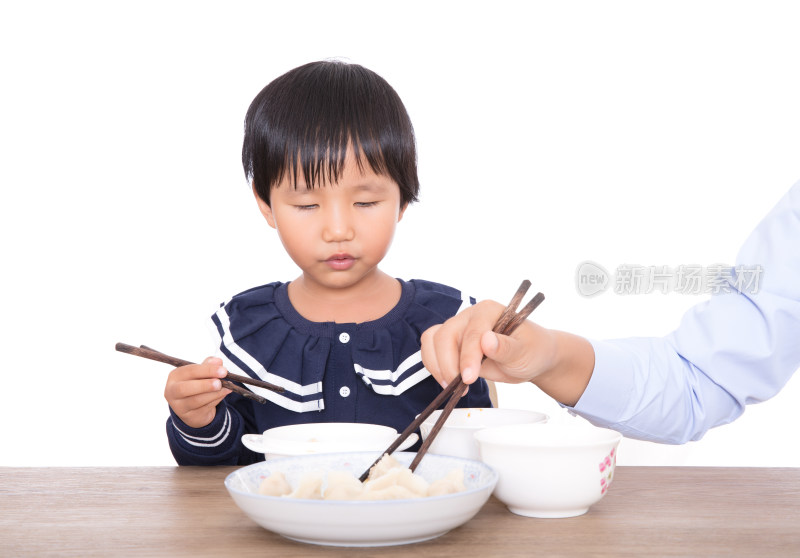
[242,61,419,205]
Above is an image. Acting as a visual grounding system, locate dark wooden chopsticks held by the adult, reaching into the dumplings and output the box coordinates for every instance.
[359,279,544,482]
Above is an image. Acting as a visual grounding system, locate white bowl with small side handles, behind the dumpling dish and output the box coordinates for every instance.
[242,422,419,460]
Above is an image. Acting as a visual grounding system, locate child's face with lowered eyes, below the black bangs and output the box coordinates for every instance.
[256,151,405,298]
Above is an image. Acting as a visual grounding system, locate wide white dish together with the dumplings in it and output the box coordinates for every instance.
[225,452,498,547]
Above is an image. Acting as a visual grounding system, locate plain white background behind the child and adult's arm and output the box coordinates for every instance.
[0,1,800,466]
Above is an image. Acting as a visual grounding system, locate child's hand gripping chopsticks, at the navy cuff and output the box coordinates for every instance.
[164,357,231,428]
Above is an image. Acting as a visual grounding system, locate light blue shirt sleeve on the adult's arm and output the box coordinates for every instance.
[573,182,800,444]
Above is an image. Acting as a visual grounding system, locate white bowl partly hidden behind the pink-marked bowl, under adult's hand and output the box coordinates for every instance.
[419,407,549,461]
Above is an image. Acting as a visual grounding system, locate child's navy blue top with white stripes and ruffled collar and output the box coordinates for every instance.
[167,280,492,465]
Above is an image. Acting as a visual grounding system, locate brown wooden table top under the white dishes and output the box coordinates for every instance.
[0,467,800,558]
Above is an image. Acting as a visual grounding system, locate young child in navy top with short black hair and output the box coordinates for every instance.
[164,62,491,465]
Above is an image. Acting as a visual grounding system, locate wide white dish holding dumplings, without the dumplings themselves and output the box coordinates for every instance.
[225,452,497,546]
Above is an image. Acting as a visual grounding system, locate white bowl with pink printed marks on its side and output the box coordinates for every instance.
[475,423,622,517]
